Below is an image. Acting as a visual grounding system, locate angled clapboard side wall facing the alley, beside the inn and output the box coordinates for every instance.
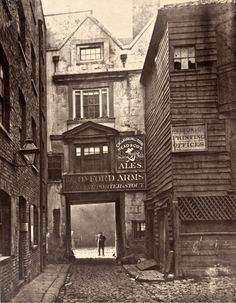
[145,28,172,200]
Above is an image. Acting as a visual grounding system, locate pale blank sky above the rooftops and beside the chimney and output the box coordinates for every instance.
[41,0,192,38]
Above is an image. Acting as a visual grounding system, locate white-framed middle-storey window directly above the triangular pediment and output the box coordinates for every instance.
[73,87,109,119]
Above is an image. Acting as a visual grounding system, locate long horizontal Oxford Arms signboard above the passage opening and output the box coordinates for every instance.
[63,172,146,193]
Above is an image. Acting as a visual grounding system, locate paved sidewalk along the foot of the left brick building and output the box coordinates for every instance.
[11,264,70,303]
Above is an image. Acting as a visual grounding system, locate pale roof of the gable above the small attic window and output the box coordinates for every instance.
[45,11,123,50]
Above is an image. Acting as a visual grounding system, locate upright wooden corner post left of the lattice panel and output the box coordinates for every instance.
[173,201,182,277]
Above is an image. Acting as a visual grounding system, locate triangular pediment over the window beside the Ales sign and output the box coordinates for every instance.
[62,121,119,141]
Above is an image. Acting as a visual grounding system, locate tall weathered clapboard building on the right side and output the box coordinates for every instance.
[141,1,236,276]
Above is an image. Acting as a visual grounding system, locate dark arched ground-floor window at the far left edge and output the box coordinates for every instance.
[0,190,11,256]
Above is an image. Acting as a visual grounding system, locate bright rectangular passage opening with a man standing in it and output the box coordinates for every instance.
[70,202,117,259]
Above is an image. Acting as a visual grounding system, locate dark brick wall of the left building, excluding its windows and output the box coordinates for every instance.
[0,0,46,301]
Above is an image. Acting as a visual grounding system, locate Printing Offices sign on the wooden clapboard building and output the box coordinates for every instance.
[171,125,206,152]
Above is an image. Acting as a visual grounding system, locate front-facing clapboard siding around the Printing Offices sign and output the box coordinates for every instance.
[168,18,231,196]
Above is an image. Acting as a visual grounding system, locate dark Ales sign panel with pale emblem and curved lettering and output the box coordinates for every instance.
[116,135,145,171]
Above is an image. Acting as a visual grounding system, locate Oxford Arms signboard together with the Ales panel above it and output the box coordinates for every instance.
[63,135,146,193]
